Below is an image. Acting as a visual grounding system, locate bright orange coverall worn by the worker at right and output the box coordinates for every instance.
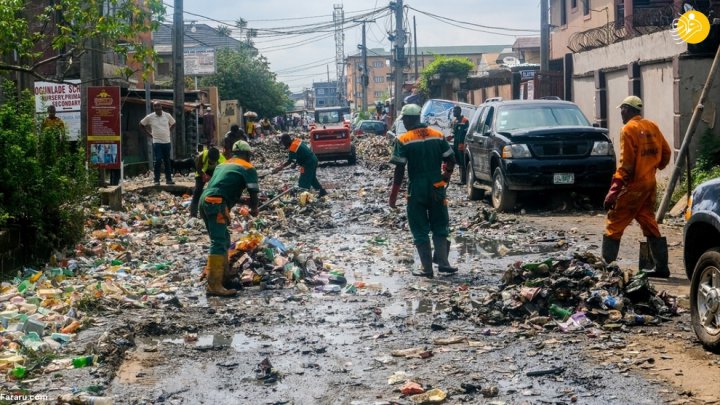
[605,115,671,240]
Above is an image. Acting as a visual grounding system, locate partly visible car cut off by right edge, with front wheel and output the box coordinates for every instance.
[683,179,720,352]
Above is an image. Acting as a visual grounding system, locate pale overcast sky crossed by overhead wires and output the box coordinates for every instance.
[176,0,540,91]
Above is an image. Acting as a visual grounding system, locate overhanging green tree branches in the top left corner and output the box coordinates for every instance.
[0,0,165,81]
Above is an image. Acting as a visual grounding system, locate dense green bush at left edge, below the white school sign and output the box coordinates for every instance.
[0,82,94,259]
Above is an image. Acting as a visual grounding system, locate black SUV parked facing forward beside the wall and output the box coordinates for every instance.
[465,98,615,211]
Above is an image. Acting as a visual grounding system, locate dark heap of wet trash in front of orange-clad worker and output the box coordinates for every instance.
[450,252,678,332]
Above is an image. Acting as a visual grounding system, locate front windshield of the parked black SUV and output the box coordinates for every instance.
[495,105,590,132]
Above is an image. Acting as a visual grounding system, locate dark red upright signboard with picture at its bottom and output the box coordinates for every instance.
[87,86,122,169]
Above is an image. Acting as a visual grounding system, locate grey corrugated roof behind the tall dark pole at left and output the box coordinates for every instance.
[153,24,242,53]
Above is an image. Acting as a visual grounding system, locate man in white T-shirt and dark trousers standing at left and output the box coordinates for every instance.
[140,101,175,186]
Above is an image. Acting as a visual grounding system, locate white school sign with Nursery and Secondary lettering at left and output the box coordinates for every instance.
[34,80,80,141]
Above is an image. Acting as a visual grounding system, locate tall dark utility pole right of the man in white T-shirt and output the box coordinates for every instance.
[172,0,187,157]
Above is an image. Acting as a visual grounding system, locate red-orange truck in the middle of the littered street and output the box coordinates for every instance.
[310,107,357,165]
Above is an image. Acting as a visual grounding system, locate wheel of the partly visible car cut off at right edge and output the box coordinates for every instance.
[690,248,720,352]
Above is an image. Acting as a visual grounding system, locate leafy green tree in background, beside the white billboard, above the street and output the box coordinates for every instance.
[202,48,292,118]
